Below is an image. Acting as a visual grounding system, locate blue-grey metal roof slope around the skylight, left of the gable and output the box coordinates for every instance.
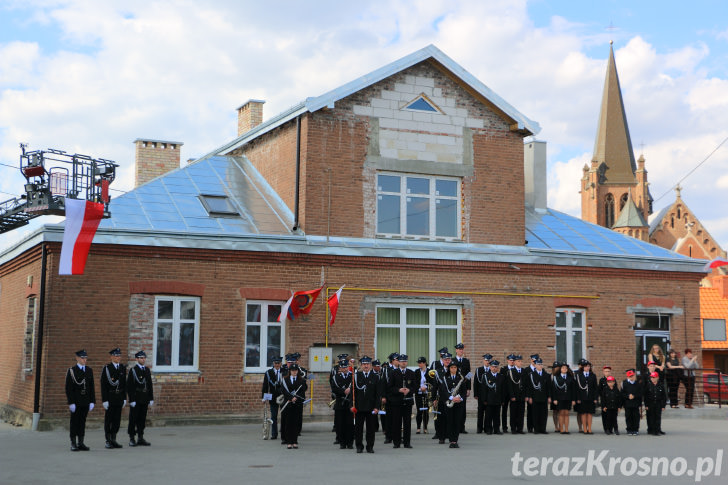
[99,157,293,235]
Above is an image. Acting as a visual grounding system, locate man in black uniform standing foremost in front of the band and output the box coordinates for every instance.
[354,355,382,453]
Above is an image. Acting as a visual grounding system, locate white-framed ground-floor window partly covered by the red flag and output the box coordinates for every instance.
[245,301,286,372]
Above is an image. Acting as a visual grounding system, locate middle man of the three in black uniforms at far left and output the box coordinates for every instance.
[101,347,126,448]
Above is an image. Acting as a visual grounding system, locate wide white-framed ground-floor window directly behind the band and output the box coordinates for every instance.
[374,304,462,367]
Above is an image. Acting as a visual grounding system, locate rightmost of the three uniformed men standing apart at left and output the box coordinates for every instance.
[126,350,154,446]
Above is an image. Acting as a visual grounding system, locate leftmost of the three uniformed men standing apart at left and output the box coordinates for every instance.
[66,350,96,451]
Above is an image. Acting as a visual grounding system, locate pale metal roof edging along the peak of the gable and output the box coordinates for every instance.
[203,44,541,158]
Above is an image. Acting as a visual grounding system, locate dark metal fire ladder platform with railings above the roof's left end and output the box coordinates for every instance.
[0,144,118,234]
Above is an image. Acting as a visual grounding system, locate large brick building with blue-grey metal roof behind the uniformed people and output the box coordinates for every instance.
[0,46,703,419]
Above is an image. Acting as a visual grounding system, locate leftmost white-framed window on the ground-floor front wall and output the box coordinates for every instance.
[153,296,200,372]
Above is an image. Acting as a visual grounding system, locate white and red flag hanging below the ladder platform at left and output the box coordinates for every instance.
[58,198,104,275]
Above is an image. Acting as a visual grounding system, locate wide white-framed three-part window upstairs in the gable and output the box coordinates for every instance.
[377,172,460,239]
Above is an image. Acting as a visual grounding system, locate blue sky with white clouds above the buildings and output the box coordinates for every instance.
[0,0,728,252]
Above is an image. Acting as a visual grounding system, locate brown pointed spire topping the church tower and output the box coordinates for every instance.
[592,42,637,184]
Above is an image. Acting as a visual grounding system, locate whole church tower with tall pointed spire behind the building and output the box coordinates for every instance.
[580,42,652,241]
